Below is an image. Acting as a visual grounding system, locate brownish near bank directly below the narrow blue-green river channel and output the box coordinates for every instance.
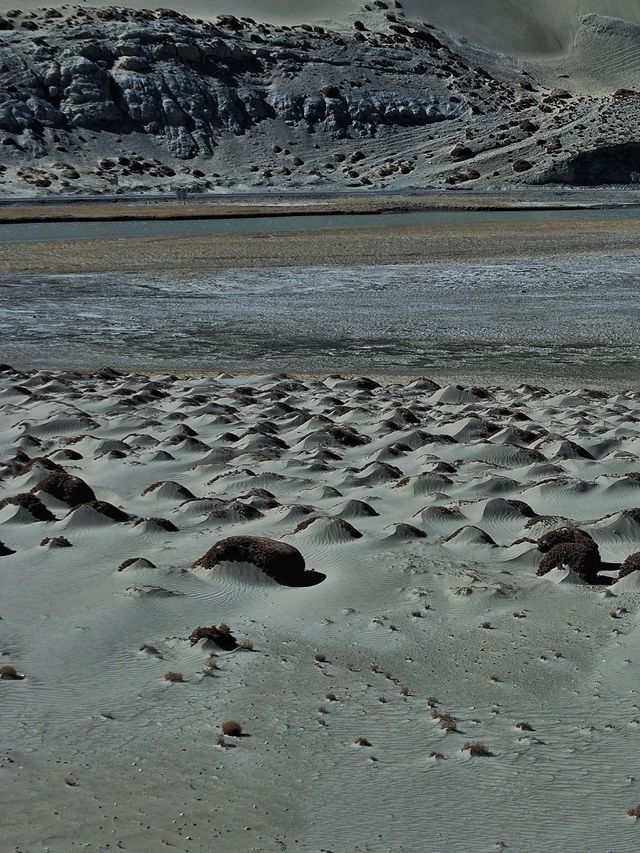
[0,210,640,273]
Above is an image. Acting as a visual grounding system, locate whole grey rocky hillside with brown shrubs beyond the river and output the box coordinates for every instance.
[0,0,640,194]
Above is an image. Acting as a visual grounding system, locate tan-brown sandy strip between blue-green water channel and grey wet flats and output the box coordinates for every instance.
[0,211,640,273]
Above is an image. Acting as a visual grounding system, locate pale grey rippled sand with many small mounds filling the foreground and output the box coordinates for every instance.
[0,362,640,853]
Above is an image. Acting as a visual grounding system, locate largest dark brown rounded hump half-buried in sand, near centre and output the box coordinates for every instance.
[193,536,326,587]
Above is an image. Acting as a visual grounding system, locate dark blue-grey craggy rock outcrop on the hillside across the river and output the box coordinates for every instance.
[0,8,464,159]
